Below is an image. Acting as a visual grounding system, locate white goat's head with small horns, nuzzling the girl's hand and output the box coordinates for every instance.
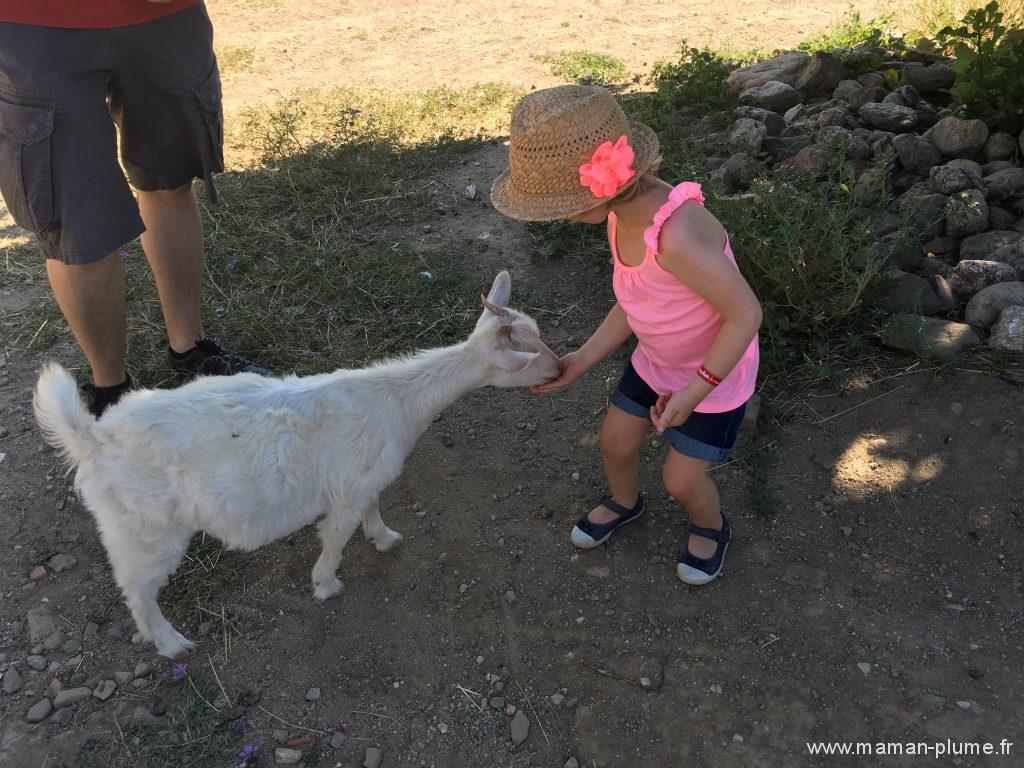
[470,272,558,387]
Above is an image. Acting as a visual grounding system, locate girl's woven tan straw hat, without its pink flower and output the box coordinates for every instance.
[490,85,658,221]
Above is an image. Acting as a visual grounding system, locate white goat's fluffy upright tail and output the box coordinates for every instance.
[32,360,97,466]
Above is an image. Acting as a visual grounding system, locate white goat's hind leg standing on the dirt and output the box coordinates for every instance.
[102,526,196,658]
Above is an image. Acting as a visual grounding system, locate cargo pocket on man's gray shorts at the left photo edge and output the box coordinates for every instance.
[0,94,53,233]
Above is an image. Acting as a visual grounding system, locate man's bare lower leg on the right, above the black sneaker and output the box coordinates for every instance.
[138,184,203,353]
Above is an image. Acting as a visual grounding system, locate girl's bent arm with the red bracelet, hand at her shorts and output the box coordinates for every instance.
[651,205,762,432]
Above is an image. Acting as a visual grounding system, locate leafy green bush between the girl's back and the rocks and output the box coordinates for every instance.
[708,152,888,374]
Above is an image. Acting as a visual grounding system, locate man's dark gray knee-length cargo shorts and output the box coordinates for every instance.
[0,3,223,264]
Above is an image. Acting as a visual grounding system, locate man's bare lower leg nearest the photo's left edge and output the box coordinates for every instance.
[46,251,126,387]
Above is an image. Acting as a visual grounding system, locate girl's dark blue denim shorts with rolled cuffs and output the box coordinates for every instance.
[611,360,746,462]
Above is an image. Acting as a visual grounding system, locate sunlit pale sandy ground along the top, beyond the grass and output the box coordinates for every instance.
[209,0,889,106]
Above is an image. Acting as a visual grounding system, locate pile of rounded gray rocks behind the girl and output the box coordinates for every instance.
[711,51,1024,356]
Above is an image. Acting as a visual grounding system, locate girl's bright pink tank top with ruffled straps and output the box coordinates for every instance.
[608,181,759,414]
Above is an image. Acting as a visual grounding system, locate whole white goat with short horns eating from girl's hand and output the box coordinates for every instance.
[34,272,558,658]
